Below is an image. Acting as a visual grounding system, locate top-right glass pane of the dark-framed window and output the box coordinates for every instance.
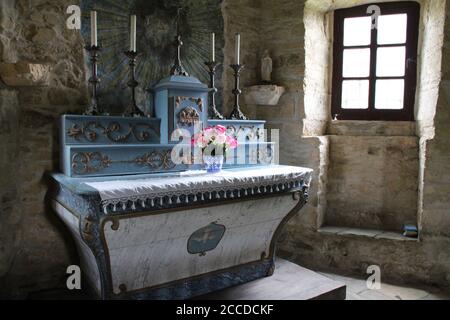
[378,13,408,44]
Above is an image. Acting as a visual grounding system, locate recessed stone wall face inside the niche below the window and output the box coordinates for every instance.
[325,135,419,233]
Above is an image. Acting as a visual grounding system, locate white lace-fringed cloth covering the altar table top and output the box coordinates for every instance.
[85,166,312,213]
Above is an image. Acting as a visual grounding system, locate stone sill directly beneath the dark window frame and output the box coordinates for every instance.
[327,120,416,137]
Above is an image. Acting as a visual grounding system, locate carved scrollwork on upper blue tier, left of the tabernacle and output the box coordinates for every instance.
[67,121,156,142]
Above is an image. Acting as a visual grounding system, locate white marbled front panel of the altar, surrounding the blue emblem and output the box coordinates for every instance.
[103,195,298,294]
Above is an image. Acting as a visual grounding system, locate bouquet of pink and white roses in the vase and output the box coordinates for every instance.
[191,125,238,156]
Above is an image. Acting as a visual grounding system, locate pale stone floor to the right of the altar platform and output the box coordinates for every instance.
[319,272,450,300]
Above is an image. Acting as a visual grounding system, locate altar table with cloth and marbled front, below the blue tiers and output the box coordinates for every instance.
[48,166,311,299]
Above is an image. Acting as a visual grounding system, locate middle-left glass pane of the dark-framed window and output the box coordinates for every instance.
[342,49,370,78]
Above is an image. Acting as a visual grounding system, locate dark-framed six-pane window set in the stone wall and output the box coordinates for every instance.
[332,1,420,121]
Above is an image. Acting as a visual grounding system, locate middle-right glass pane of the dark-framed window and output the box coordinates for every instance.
[377,47,406,77]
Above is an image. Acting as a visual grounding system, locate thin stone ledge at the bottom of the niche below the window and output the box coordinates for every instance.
[318,227,420,242]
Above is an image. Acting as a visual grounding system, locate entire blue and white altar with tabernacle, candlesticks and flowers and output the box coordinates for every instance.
[48,12,312,299]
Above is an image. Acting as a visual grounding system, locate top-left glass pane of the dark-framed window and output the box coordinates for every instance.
[344,17,372,46]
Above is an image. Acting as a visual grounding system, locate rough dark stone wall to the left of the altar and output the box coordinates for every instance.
[0,0,87,297]
